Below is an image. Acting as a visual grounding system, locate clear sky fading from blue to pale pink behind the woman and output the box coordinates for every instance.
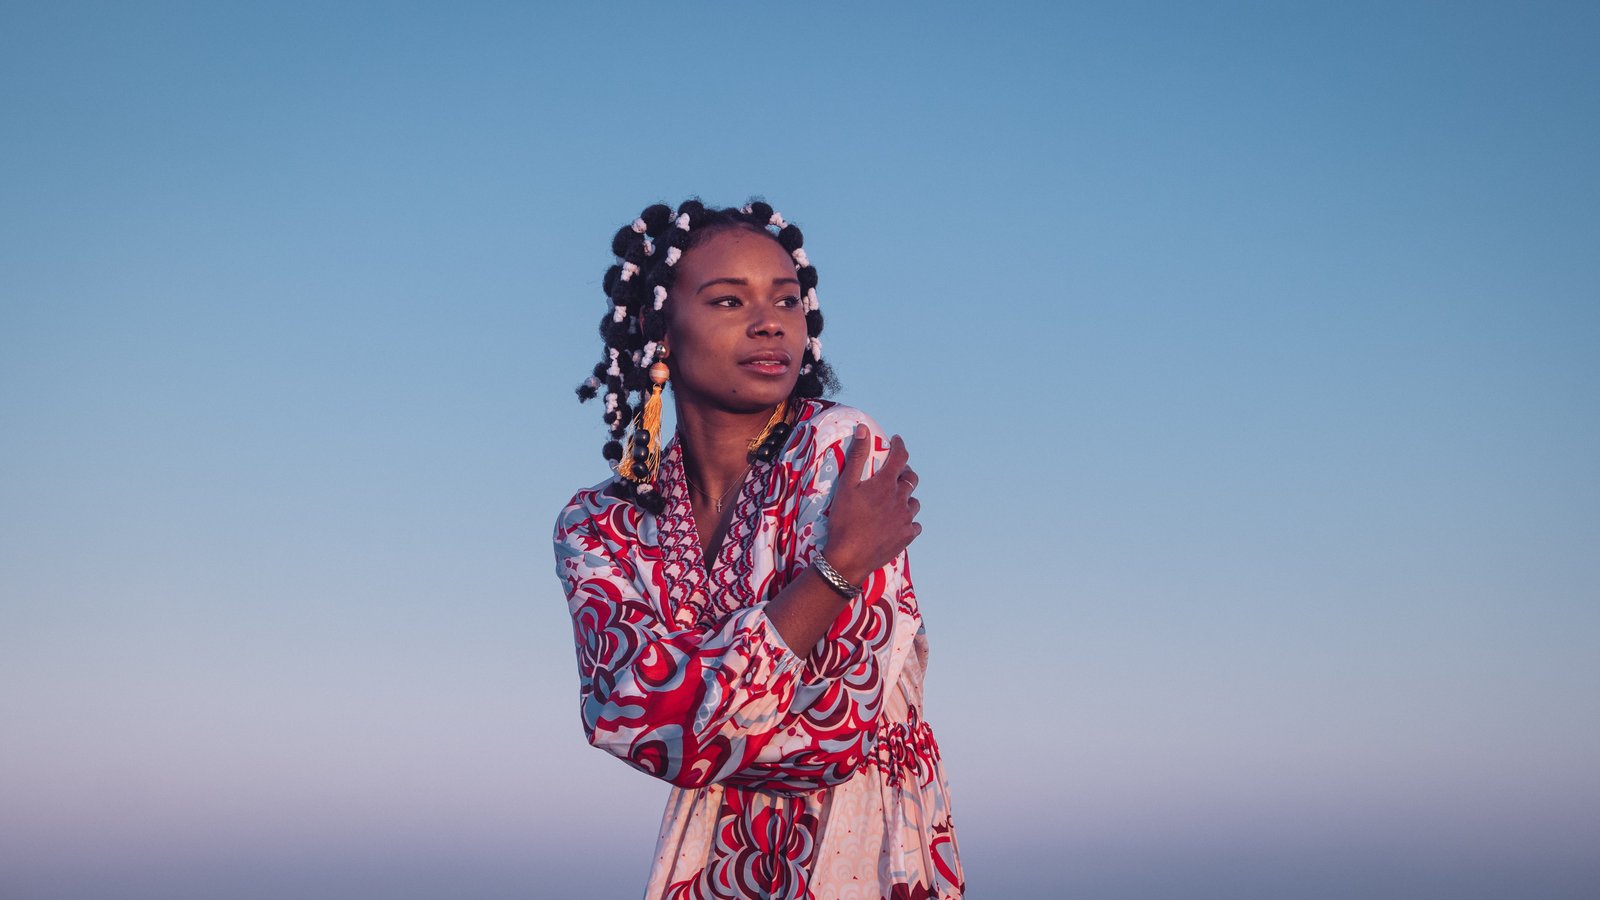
[0,0,1600,900]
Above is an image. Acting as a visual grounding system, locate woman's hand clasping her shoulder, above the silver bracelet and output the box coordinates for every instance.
[822,424,922,585]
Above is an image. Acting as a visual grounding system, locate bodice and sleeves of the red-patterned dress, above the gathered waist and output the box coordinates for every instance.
[555,407,918,794]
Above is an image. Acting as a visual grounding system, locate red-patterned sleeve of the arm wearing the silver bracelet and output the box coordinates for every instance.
[555,492,802,788]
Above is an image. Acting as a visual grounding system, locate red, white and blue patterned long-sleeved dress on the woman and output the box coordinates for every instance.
[555,400,963,900]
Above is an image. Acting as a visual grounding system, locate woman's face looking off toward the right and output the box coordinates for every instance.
[666,229,806,413]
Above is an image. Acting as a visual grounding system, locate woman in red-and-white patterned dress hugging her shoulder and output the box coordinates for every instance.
[555,200,963,900]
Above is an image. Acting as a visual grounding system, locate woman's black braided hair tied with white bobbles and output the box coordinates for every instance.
[578,200,838,514]
